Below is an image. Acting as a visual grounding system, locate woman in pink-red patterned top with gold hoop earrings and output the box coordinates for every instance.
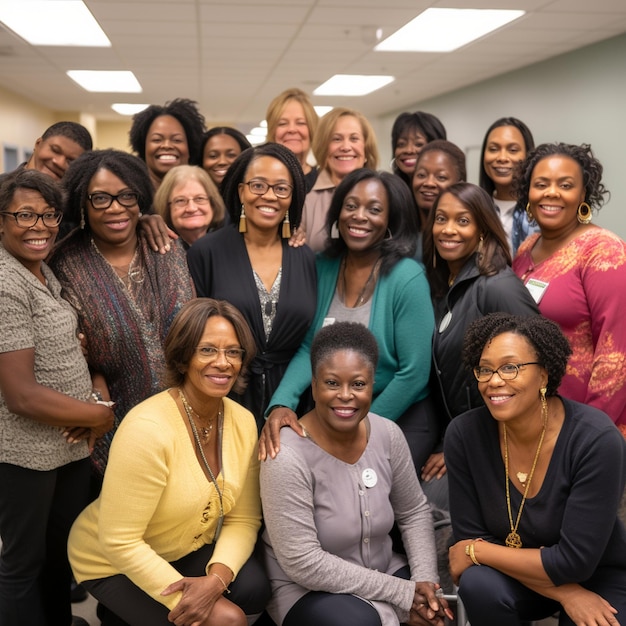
[513,143,626,436]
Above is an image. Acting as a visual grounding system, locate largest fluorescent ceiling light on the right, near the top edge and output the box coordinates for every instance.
[374,9,524,52]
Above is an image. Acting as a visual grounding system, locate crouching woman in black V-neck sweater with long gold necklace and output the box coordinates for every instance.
[445,313,626,626]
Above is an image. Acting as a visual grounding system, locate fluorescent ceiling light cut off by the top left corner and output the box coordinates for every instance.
[0,0,111,48]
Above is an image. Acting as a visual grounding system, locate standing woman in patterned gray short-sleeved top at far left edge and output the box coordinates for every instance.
[0,170,113,626]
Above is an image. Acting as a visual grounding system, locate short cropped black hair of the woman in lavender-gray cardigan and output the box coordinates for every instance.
[311,322,378,377]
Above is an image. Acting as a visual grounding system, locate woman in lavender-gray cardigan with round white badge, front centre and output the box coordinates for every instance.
[261,322,451,626]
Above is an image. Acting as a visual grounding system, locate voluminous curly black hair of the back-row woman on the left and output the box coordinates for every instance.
[128,98,205,165]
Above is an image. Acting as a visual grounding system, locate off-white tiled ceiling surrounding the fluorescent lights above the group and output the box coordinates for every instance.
[0,0,626,130]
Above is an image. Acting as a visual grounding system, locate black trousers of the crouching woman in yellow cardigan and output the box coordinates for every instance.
[83,544,271,626]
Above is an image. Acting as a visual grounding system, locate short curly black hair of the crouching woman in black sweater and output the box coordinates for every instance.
[463,313,572,396]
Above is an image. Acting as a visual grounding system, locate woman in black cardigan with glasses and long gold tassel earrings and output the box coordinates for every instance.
[187,143,316,429]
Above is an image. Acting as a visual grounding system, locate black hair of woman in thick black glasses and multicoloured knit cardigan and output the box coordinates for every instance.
[62,150,154,230]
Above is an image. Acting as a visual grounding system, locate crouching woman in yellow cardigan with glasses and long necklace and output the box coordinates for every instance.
[69,298,269,626]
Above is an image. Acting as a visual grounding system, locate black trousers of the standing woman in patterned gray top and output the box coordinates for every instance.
[0,459,90,626]
